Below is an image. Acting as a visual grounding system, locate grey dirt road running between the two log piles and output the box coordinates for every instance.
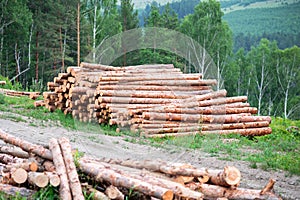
[0,112,300,200]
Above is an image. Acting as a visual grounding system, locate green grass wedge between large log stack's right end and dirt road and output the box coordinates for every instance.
[151,118,300,175]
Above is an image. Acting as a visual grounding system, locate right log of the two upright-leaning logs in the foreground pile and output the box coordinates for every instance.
[58,137,84,200]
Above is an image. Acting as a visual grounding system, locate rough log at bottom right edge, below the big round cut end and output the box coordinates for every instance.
[187,182,281,200]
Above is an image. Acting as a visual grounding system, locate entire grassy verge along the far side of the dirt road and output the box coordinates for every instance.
[0,94,300,175]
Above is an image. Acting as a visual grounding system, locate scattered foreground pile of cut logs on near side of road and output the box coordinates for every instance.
[0,129,280,200]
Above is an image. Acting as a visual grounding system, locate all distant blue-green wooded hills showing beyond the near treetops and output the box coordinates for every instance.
[139,0,300,51]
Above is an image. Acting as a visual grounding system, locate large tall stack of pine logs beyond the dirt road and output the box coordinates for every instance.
[36,63,272,137]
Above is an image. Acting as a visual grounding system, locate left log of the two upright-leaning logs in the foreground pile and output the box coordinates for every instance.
[49,138,72,200]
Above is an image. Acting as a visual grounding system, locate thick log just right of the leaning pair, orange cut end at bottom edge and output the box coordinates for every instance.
[79,159,173,200]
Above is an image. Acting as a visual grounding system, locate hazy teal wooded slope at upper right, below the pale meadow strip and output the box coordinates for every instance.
[223,2,300,50]
